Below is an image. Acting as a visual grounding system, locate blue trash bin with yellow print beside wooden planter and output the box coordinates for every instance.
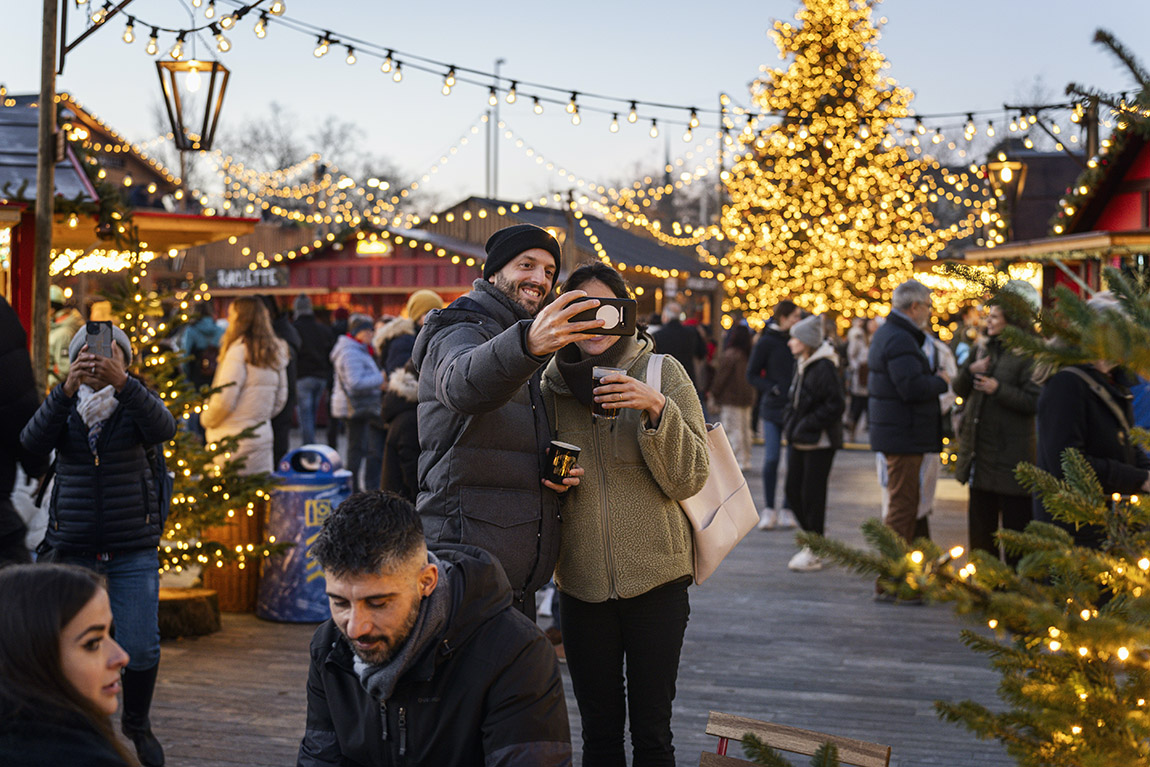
[255,445,352,623]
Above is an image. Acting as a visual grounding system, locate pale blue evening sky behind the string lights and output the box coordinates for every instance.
[0,0,1150,204]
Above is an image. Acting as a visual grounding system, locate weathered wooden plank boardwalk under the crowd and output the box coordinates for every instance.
[143,448,1012,767]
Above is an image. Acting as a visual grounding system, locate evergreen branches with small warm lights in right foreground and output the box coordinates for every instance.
[799,269,1150,767]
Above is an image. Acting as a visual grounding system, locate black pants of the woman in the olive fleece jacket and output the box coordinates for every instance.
[559,578,691,767]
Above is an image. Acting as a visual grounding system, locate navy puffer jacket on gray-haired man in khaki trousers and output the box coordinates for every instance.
[867,312,946,454]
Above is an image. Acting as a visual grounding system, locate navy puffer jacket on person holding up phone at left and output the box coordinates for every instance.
[20,376,176,552]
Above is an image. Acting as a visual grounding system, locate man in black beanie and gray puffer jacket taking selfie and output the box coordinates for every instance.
[412,224,603,619]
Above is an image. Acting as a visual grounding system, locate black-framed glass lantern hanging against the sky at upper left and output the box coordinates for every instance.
[155,60,231,151]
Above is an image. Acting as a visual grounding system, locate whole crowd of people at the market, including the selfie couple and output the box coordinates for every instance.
[0,224,1150,767]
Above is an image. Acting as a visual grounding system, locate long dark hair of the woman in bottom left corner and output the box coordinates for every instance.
[0,565,138,765]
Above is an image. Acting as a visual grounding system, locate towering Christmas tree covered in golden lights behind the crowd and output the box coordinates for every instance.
[722,0,994,319]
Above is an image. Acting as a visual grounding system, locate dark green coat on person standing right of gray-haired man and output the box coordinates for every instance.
[953,338,1041,496]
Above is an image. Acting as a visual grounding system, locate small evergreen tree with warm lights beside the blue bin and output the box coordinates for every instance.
[104,263,282,573]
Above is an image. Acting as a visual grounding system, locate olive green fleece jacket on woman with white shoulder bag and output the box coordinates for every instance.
[543,338,710,603]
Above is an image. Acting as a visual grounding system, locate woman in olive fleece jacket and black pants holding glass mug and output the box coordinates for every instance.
[543,262,708,767]
